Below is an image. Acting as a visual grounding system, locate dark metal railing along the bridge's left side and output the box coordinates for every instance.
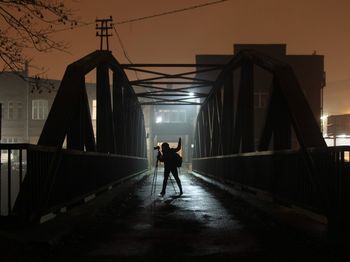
[0,144,147,221]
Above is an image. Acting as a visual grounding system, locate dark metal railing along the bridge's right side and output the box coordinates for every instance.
[192,146,350,215]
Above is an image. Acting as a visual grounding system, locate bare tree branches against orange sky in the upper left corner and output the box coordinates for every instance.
[0,0,77,71]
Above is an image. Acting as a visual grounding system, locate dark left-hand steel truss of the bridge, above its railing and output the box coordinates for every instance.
[38,51,146,157]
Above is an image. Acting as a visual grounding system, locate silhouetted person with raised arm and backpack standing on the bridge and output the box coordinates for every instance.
[157,137,183,196]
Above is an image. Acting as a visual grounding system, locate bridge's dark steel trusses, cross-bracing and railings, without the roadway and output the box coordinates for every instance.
[1,51,350,237]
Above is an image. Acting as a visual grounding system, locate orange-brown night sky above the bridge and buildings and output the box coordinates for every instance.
[26,0,350,114]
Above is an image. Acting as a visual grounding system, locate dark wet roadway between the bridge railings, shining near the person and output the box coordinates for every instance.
[0,169,341,262]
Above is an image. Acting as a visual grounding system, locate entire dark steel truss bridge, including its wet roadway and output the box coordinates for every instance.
[0,50,350,261]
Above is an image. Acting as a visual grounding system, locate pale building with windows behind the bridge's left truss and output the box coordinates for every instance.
[0,70,96,144]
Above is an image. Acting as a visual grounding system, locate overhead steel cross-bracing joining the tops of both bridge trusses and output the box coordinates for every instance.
[122,64,223,105]
